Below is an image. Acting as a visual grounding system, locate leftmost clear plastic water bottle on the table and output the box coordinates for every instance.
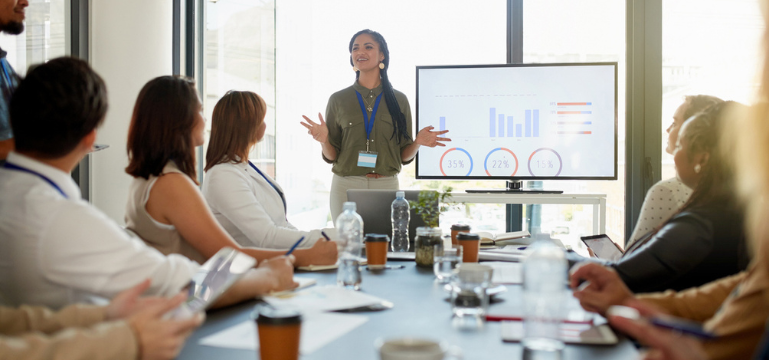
[336,202,363,290]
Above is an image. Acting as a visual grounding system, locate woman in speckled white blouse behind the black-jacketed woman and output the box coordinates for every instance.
[627,95,723,246]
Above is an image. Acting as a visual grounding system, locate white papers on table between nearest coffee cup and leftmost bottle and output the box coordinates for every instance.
[263,285,387,312]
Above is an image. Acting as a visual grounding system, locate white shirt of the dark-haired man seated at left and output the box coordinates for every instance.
[0,152,199,308]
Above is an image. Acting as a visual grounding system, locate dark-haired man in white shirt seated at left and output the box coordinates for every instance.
[0,58,295,308]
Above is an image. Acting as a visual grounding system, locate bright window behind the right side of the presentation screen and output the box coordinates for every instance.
[523,0,632,247]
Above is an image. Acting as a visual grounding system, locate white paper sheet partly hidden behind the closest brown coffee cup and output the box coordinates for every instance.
[200,313,368,355]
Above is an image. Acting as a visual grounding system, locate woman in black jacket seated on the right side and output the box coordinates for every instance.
[572,102,749,292]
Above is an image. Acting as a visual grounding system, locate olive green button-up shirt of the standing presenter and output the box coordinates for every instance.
[323,81,413,176]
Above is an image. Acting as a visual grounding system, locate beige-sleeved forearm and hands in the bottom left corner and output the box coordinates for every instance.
[0,281,203,360]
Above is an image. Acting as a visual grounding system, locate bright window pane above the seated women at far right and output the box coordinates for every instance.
[662,0,764,179]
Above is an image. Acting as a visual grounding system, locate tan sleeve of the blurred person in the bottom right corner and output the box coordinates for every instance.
[638,259,769,360]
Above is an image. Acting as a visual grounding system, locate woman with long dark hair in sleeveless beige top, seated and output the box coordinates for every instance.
[126,76,336,266]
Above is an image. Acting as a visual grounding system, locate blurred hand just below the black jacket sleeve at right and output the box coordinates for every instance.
[569,263,635,315]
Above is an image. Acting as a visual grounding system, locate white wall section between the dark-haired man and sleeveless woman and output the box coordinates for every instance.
[89,0,173,224]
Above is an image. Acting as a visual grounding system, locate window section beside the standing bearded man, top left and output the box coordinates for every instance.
[0,0,69,76]
